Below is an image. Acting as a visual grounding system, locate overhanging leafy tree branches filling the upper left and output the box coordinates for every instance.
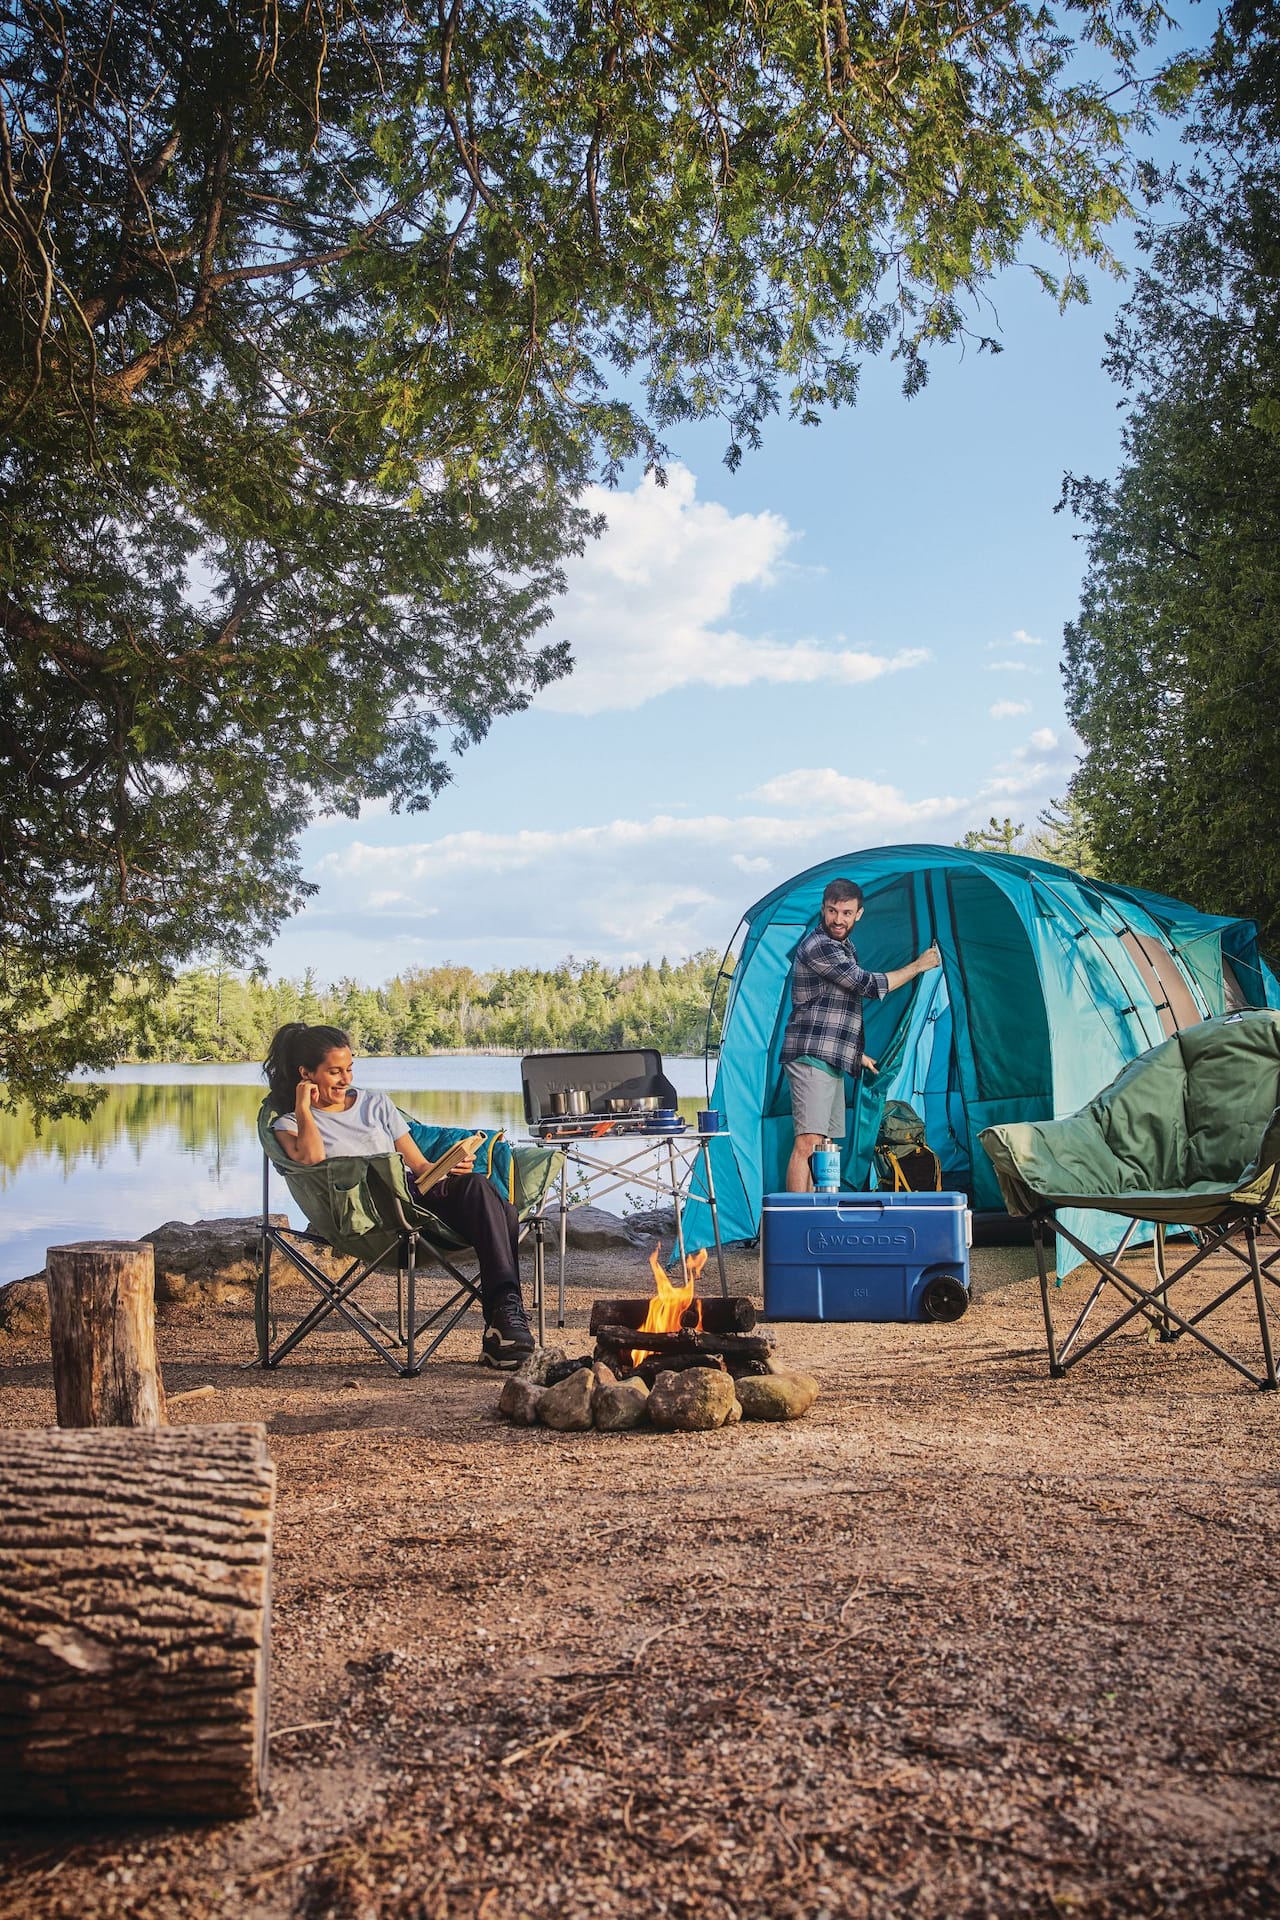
[0,0,1159,1110]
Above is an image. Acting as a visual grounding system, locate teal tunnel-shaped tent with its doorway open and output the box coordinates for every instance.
[687,847,1280,1242]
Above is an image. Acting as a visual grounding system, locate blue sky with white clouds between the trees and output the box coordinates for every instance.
[269,105,1182,981]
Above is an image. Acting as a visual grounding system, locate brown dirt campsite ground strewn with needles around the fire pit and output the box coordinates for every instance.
[0,1250,1280,1920]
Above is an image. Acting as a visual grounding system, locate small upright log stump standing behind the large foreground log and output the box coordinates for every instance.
[44,1240,167,1427]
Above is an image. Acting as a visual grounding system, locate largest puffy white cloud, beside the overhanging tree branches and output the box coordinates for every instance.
[535,465,929,714]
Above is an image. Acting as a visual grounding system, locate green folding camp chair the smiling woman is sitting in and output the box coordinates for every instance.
[255,1100,560,1379]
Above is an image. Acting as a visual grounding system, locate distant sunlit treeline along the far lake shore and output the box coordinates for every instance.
[132,950,723,1060]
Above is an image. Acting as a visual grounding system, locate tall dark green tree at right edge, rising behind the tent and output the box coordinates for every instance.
[1065,6,1280,947]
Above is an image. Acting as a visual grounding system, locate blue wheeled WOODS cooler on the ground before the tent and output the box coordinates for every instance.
[760,1192,973,1321]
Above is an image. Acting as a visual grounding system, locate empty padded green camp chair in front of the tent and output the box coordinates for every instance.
[979,1012,1280,1390]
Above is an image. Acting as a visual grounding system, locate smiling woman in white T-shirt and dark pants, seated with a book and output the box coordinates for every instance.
[263,1020,533,1367]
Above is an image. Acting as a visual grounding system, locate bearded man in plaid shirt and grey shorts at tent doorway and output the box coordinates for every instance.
[783,879,940,1194]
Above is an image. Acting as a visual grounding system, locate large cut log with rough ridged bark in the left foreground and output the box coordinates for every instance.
[0,1427,276,1820]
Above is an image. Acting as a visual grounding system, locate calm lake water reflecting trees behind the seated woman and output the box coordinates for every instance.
[0,1054,706,1284]
